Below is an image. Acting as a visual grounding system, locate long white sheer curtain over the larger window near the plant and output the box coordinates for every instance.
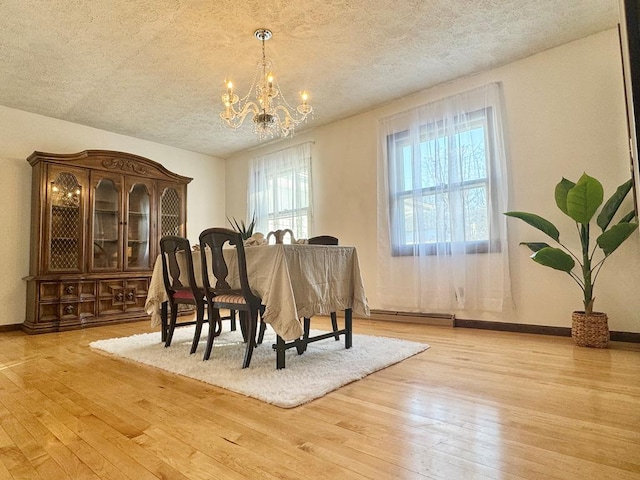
[377,83,511,313]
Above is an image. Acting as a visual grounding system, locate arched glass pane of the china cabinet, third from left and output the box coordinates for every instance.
[126,183,151,269]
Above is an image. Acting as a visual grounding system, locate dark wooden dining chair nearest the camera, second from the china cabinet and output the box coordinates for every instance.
[200,227,262,368]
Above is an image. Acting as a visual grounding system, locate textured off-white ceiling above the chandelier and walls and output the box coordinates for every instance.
[0,0,618,158]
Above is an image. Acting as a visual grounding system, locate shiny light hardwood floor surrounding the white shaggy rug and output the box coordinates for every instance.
[0,319,640,480]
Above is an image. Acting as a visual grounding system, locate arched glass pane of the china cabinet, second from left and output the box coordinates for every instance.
[93,179,122,270]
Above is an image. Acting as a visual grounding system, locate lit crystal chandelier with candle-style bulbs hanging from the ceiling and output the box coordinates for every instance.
[220,28,313,140]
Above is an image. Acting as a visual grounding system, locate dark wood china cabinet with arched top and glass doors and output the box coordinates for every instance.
[23,150,191,333]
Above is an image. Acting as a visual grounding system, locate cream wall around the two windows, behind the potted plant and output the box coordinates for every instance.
[226,30,640,332]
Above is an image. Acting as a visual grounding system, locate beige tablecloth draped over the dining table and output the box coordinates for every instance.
[145,245,369,341]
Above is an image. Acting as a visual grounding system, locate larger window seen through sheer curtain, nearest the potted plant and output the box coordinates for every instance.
[388,107,499,255]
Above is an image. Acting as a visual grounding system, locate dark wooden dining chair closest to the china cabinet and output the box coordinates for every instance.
[160,235,205,353]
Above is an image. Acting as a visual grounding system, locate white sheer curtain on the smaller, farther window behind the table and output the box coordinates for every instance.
[248,142,312,238]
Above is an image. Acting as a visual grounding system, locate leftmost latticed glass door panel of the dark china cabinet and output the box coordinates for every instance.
[47,172,83,272]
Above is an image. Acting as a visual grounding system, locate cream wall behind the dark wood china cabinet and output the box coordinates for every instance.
[0,106,225,325]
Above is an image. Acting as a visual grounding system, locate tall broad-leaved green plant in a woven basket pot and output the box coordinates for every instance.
[505,173,638,348]
